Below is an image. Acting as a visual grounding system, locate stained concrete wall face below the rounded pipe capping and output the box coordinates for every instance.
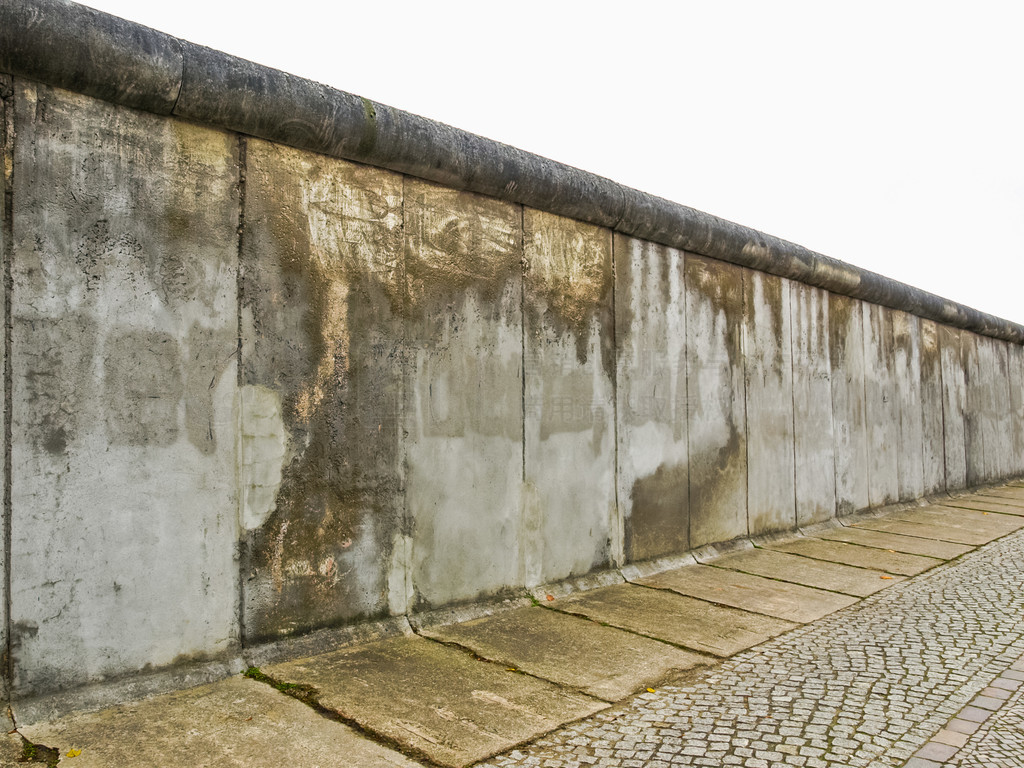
[6,64,1024,699]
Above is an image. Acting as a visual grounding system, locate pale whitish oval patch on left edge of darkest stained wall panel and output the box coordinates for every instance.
[239,385,288,530]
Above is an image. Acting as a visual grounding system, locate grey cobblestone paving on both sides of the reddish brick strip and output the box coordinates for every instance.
[482,532,1024,768]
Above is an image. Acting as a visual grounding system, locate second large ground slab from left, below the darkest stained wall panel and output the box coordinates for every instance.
[263,636,607,766]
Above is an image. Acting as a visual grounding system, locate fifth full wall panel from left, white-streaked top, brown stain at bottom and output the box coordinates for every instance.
[614,234,689,562]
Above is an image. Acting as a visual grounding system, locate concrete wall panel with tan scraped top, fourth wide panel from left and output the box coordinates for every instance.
[522,209,621,586]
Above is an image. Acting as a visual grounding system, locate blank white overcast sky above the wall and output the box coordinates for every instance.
[81,0,1024,323]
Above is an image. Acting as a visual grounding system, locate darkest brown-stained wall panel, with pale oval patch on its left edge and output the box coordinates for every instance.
[241,139,406,641]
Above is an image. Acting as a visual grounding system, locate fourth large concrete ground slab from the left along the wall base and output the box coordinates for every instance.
[550,584,798,656]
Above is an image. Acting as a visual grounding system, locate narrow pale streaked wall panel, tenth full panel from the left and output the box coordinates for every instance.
[862,304,900,507]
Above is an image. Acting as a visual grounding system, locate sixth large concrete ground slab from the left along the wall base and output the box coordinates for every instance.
[713,549,903,597]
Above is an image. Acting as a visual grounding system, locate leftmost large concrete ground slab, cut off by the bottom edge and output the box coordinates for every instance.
[20,677,418,768]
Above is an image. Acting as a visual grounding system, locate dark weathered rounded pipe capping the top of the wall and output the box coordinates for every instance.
[0,0,1024,344]
